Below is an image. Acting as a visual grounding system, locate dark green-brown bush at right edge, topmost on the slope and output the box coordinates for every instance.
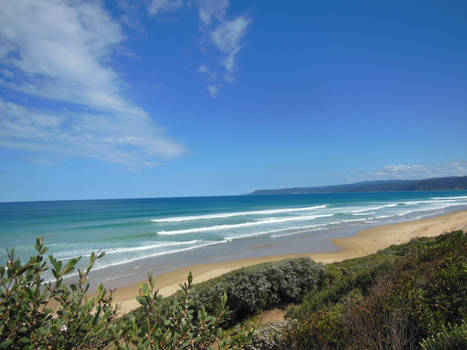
[371,231,467,343]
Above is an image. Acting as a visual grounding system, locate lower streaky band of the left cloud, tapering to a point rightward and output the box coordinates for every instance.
[0,100,183,170]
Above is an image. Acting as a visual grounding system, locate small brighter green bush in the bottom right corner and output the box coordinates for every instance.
[420,320,467,350]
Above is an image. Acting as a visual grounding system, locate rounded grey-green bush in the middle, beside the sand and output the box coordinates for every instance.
[188,258,326,325]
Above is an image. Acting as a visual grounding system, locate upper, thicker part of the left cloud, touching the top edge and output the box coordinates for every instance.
[0,0,126,113]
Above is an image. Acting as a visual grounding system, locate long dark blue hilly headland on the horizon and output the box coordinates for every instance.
[250,176,467,195]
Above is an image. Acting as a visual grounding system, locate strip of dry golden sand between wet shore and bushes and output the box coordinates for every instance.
[114,210,467,313]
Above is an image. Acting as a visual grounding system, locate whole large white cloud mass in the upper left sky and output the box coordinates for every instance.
[0,0,184,169]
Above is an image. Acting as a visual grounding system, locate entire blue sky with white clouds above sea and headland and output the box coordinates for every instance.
[0,0,467,201]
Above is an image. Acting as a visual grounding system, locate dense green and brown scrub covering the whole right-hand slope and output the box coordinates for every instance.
[283,231,467,349]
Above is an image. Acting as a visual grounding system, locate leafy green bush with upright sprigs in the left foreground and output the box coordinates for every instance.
[0,239,251,350]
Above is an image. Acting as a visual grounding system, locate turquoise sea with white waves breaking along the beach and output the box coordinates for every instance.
[0,191,467,278]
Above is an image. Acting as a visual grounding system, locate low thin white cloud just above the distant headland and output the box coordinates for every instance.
[347,160,467,181]
